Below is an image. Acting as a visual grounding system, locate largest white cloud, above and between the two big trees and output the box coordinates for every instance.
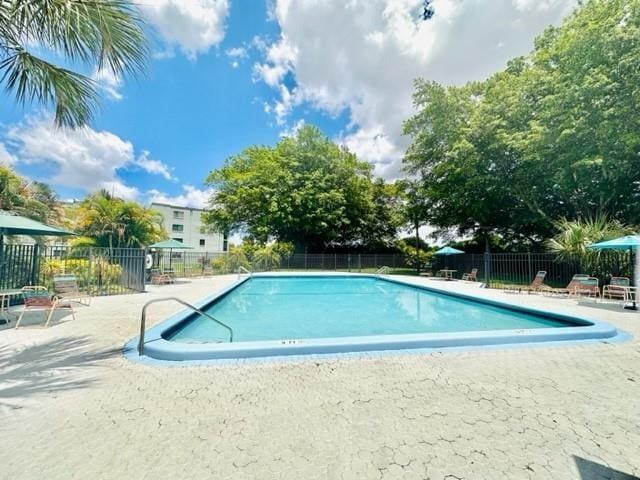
[254,0,576,178]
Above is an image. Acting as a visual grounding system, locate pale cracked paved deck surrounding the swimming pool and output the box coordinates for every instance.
[0,276,640,480]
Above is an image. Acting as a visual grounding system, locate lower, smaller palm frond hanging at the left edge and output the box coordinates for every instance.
[0,50,98,128]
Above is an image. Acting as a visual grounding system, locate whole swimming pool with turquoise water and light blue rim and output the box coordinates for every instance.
[134,275,617,360]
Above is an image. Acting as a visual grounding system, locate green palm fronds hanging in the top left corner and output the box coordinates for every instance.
[0,0,147,128]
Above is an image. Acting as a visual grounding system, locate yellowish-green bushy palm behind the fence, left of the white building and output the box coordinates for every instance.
[73,191,167,248]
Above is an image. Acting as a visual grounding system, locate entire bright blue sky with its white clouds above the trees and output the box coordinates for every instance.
[0,0,575,206]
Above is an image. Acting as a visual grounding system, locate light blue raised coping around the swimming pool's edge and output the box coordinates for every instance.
[125,272,626,364]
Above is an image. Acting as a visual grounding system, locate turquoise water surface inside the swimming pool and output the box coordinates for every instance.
[163,277,576,343]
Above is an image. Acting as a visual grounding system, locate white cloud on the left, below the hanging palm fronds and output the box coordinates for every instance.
[5,117,172,199]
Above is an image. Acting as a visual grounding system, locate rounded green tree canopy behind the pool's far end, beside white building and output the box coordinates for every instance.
[206,125,397,251]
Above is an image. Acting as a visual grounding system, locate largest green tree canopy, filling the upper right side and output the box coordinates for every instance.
[404,0,640,248]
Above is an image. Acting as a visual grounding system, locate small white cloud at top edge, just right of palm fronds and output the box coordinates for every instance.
[139,0,229,59]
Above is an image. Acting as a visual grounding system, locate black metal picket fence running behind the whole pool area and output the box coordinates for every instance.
[0,244,633,295]
